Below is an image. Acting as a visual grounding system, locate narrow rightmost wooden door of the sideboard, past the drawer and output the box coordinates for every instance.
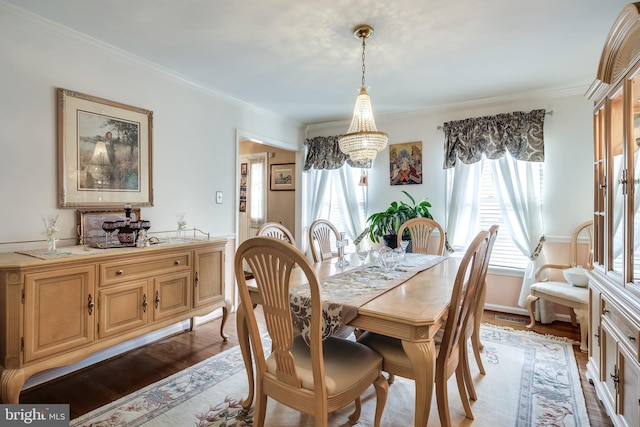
[193,245,224,308]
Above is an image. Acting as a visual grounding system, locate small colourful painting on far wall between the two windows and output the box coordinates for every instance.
[389,141,422,185]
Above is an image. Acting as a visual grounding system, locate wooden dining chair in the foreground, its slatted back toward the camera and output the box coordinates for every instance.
[235,237,389,427]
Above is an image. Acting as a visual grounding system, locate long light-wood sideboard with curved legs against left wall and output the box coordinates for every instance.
[0,239,231,404]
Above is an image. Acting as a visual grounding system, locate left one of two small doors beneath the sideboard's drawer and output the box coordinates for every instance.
[98,280,150,338]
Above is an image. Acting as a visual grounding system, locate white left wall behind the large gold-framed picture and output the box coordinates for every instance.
[0,2,304,251]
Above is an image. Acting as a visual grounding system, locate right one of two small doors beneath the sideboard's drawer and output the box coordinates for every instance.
[153,271,191,320]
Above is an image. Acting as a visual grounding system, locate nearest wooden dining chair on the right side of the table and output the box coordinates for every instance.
[358,231,490,426]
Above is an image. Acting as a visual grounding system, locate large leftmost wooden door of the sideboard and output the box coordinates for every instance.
[24,265,95,362]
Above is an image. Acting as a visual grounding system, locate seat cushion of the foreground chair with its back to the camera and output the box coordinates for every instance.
[267,335,382,395]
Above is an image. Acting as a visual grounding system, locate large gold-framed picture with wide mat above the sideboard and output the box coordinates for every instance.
[57,88,153,208]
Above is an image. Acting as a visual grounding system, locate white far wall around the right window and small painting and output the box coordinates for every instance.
[307,93,595,237]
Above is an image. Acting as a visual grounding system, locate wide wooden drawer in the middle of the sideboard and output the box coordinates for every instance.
[100,252,191,286]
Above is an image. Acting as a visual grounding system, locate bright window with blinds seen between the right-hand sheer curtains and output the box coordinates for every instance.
[447,158,542,270]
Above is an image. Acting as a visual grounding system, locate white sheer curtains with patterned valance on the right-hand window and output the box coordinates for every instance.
[444,110,555,321]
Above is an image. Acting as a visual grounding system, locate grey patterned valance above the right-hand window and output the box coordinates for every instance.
[443,110,545,169]
